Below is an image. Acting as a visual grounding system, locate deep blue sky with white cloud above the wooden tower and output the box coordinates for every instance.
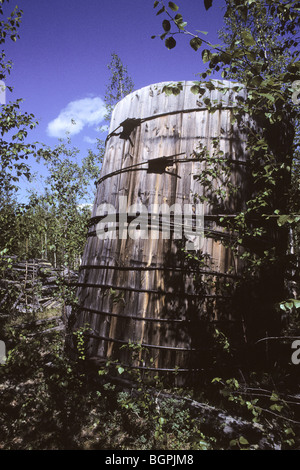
[5,0,224,198]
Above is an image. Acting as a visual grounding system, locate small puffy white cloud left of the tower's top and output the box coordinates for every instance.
[47,97,105,138]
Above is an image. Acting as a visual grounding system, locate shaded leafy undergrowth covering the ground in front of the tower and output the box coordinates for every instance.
[0,324,299,450]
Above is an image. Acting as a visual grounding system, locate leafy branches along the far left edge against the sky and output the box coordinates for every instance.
[0,1,37,257]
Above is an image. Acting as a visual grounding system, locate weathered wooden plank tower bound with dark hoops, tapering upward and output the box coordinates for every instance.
[69,81,248,380]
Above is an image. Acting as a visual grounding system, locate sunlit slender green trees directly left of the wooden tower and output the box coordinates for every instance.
[31,142,102,268]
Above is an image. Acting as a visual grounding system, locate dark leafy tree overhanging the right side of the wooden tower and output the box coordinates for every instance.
[154,0,300,360]
